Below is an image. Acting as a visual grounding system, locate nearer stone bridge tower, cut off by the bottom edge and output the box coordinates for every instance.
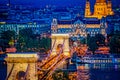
[5,53,38,80]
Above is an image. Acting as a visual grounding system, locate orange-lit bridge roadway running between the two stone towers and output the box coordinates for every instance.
[37,53,67,80]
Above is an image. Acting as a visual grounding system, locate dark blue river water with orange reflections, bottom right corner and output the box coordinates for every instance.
[77,64,120,80]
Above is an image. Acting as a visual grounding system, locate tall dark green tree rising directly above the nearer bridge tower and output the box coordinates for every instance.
[17,28,34,51]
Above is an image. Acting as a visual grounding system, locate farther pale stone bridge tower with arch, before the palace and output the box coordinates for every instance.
[51,34,70,56]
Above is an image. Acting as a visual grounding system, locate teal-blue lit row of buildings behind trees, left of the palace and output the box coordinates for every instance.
[0,20,51,34]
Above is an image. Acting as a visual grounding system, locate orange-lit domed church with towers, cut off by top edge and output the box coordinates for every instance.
[85,0,114,19]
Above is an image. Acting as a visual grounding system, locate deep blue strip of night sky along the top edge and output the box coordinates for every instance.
[0,0,120,7]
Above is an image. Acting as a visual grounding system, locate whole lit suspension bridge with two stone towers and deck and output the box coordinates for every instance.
[5,34,70,80]
